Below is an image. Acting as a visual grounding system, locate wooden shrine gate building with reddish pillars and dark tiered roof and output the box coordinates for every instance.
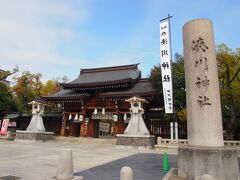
[42,64,159,137]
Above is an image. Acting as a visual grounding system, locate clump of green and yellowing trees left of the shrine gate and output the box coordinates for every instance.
[0,68,68,117]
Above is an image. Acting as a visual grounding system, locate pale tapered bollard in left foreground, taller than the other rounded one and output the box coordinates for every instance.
[56,149,73,180]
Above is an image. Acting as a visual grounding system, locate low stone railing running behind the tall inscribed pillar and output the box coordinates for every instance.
[155,137,240,149]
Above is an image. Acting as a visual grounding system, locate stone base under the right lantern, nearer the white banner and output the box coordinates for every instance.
[116,134,156,149]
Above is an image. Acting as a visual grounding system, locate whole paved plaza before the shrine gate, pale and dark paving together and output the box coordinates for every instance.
[0,138,177,180]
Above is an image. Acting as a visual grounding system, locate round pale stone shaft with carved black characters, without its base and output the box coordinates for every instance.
[183,19,223,147]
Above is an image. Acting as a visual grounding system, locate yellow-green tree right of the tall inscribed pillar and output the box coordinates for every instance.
[217,44,240,139]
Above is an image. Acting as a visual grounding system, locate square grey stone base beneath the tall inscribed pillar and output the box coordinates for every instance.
[178,146,239,180]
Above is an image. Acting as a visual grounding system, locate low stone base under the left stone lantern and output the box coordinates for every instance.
[15,131,54,142]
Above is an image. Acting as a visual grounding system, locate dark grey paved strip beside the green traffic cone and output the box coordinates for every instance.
[75,153,177,180]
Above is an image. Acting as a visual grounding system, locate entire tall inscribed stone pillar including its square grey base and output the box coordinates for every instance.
[178,19,239,180]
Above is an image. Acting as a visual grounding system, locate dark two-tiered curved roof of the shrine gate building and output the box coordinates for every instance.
[42,64,157,102]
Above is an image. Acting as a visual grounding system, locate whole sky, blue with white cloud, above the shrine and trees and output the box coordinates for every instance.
[0,0,240,81]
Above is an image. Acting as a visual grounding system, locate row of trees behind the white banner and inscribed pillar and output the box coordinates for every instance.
[150,44,240,139]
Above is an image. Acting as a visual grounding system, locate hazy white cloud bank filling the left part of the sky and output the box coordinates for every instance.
[0,0,89,80]
